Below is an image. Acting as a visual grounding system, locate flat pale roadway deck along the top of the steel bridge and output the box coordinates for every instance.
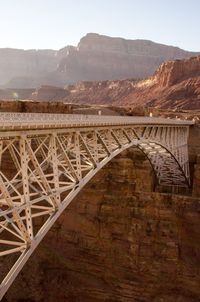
[0,112,194,130]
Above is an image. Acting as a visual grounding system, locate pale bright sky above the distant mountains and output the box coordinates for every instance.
[0,0,200,51]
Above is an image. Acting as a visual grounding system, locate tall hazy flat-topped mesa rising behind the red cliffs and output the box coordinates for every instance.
[59,33,198,82]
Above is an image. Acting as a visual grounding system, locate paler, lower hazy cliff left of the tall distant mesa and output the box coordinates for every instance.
[0,48,59,88]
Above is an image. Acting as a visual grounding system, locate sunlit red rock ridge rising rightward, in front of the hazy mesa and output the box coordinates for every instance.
[57,56,200,110]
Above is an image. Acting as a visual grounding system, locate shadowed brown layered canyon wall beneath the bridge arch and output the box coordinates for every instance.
[3,150,200,302]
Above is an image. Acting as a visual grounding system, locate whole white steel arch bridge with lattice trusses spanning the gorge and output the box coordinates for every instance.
[0,113,192,299]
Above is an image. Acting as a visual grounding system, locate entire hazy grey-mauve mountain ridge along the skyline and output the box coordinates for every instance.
[0,33,200,88]
